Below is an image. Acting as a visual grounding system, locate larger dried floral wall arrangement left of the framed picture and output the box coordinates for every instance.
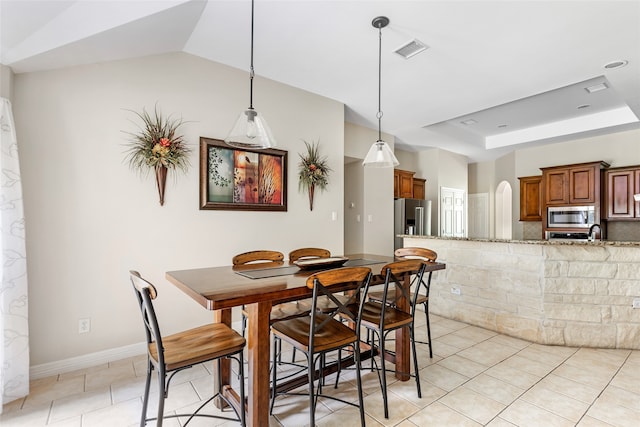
[126,106,191,206]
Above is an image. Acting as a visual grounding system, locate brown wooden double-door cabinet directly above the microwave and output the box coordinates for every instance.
[541,161,609,206]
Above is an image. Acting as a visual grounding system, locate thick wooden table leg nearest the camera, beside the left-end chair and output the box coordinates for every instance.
[245,301,271,426]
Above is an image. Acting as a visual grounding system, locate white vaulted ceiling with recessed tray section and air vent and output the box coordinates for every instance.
[0,0,640,161]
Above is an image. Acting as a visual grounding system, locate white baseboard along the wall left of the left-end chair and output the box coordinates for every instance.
[29,342,146,380]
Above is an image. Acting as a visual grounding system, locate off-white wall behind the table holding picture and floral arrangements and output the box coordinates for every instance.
[13,54,348,365]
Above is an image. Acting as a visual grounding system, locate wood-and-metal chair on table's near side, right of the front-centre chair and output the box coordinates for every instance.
[361,259,425,418]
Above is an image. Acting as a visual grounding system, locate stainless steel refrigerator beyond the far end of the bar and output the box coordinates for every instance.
[393,199,431,251]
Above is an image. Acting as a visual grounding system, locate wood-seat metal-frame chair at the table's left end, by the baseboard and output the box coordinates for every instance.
[129,271,246,427]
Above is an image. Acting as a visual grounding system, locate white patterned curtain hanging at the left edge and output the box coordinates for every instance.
[0,98,29,413]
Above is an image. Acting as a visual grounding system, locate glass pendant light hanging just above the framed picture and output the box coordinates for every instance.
[224,0,276,149]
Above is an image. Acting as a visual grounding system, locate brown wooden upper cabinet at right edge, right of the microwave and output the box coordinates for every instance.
[604,166,640,220]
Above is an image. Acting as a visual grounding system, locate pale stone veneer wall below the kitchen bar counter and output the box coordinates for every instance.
[403,236,640,349]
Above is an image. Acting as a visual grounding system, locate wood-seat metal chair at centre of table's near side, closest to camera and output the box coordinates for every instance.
[270,267,371,427]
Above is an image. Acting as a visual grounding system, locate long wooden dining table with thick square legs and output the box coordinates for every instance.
[166,254,445,426]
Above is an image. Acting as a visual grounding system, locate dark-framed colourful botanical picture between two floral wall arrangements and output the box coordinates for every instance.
[200,137,287,211]
